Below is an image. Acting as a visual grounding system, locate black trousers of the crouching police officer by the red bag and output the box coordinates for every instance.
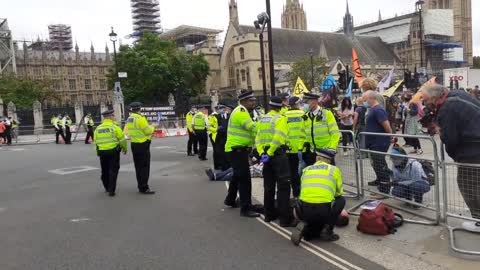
[297,196,346,236]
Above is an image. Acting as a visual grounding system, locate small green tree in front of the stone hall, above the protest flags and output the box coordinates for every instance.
[287,56,328,87]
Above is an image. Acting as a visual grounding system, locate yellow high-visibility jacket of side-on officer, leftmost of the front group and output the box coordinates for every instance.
[225,105,257,153]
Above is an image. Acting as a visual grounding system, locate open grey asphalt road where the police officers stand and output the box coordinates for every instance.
[0,137,383,270]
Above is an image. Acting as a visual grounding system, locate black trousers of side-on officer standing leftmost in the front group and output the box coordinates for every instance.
[225,148,252,211]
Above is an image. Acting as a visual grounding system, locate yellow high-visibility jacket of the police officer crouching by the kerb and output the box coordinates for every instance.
[300,161,343,203]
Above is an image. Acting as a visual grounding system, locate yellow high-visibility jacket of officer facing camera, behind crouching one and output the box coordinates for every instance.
[304,108,340,153]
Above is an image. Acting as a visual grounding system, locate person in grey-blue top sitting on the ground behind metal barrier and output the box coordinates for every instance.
[390,146,430,209]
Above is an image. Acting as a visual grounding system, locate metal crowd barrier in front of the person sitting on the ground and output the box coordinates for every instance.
[349,132,441,225]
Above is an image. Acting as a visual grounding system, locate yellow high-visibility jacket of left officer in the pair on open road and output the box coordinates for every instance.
[93,119,127,151]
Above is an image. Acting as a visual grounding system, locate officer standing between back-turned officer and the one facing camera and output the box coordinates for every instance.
[285,97,307,198]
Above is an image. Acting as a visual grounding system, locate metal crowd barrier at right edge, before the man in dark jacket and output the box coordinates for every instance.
[441,149,480,256]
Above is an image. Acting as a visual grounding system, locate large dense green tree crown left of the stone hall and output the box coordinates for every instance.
[109,33,210,103]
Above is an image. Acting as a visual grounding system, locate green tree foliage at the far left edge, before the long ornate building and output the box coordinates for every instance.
[0,77,58,109]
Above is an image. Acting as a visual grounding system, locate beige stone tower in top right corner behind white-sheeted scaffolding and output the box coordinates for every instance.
[424,0,473,66]
